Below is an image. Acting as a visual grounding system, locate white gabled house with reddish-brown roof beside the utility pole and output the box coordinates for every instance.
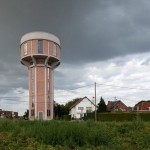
[69,97,95,119]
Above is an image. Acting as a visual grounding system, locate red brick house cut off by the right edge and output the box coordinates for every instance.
[133,100,150,112]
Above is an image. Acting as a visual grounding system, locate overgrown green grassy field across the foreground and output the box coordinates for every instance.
[0,118,150,150]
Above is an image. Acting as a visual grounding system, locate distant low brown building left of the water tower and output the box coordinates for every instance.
[0,109,18,118]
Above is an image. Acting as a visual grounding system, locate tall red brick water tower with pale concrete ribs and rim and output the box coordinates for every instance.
[20,32,60,120]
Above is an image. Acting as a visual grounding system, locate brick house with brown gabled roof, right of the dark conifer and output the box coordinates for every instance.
[107,100,128,112]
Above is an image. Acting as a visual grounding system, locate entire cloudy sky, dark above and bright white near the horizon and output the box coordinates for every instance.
[0,0,150,114]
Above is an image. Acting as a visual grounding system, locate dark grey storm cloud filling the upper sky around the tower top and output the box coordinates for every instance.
[0,0,150,95]
